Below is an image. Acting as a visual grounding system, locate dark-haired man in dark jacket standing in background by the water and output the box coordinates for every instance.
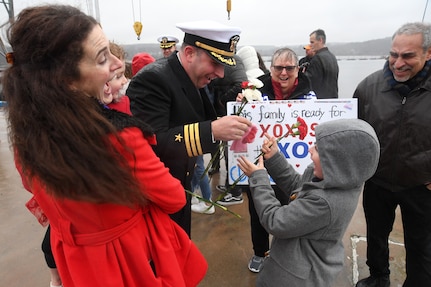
[306,29,339,99]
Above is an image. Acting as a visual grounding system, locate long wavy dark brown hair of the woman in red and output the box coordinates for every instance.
[3,5,146,206]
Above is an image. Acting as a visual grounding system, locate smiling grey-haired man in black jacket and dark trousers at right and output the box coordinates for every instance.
[353,23,431,287]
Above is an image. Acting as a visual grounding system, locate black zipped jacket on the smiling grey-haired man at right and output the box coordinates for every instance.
[353,64,431,191]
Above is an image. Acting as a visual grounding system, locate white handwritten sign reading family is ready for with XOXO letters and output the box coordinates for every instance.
[227,99,358,185]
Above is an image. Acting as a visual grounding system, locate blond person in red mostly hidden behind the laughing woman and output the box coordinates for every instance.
[104,42,132,115]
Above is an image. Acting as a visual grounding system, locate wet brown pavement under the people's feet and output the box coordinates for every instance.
[0,108,405,287]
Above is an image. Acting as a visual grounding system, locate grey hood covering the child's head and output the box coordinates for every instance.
[316,119,380,188]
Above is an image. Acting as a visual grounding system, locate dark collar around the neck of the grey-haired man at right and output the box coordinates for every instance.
[383,61,431,96]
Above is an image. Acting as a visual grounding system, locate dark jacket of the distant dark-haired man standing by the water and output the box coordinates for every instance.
[306,47,339,99]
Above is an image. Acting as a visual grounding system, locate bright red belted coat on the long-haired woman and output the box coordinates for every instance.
[19,128,207,287]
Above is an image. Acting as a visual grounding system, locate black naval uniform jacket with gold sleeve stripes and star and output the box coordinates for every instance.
[126,53,218,235]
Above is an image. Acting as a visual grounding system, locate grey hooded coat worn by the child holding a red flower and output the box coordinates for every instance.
[249,119,380,287]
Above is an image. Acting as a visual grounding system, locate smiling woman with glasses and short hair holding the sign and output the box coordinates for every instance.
[238,48,315,273]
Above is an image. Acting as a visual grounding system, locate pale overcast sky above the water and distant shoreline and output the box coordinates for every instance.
[0,0,431,46]
